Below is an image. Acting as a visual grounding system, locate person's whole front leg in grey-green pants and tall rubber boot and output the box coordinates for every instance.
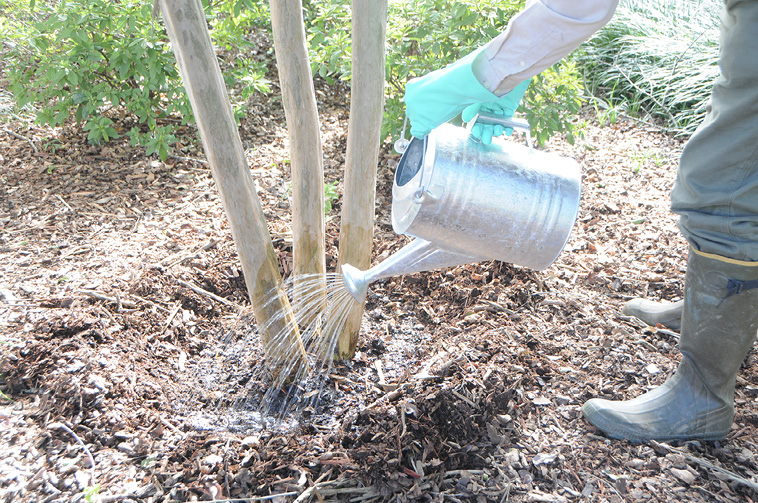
[582,0,758,441]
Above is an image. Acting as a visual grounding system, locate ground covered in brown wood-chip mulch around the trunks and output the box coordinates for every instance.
[0,79,758,503]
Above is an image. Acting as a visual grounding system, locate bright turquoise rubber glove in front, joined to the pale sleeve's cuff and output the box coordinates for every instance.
[404,48,498,139]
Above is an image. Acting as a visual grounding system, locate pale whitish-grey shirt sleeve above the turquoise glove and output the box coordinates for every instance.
[473,0,618,96]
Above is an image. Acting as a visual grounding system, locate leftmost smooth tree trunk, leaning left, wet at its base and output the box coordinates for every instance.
[160,0,307,371]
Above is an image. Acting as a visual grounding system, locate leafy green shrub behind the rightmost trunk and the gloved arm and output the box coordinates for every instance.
[305,0,582,143]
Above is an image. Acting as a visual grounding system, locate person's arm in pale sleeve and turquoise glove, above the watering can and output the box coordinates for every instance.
[404,0,618,140]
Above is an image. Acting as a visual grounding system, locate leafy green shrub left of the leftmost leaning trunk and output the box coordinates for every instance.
[4,0,191,154]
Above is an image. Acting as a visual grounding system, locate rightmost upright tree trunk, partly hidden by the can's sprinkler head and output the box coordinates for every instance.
[337,0,387,358]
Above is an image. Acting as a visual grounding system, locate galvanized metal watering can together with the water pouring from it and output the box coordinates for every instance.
[254,121,581,419]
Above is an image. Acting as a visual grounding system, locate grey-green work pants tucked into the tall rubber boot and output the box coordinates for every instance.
[671,0,758,261]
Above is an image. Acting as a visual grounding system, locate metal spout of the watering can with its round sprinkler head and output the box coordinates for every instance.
[340,239,484,303]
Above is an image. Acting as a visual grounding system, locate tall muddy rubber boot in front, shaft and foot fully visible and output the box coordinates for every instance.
[582,250,758,442]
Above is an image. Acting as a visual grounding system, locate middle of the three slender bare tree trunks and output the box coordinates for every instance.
[269,0,326,284]
